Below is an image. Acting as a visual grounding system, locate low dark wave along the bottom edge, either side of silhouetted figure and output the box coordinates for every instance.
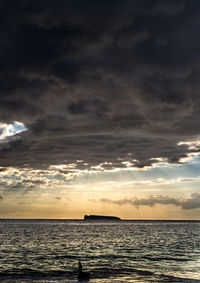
[0,267,200,283]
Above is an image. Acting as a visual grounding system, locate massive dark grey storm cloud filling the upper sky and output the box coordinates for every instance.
[0,0,200,169]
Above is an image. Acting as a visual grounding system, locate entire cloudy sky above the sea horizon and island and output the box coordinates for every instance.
[0,0,200,219]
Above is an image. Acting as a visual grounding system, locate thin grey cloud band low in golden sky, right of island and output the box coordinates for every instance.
[94,193,200,210]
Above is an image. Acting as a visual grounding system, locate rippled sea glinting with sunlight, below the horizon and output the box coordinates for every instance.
[0,220,200,283]
